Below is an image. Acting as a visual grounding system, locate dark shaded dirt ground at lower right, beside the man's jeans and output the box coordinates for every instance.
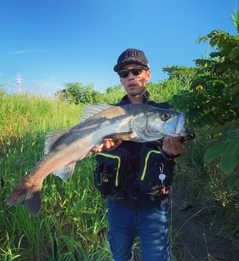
[172,197,239,261]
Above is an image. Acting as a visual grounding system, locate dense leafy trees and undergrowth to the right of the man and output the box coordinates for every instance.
[170,10,239,248]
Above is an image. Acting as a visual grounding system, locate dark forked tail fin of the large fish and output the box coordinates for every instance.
[7,179,41,216]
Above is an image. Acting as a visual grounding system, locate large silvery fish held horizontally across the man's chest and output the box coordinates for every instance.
[7,104,191,216]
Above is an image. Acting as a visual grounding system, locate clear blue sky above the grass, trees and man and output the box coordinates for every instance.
[0,0,238,95]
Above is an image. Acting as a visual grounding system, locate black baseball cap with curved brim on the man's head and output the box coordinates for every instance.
[114,48,149,72]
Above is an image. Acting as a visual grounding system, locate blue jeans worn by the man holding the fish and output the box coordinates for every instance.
[108,199,170,261]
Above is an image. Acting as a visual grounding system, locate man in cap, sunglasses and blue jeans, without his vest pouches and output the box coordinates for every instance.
[93,49,185,261]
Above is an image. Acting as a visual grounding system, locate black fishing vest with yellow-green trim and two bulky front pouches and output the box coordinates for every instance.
[94,93,175,210]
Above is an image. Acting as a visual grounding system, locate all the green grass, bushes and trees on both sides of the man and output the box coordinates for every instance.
[0,10,239,261]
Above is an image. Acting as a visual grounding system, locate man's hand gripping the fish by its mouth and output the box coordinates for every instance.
[162,137,187,156]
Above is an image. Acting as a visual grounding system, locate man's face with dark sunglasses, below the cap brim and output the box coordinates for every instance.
[120,64,151,96]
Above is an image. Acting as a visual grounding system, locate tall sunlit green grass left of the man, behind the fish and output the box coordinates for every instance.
[0,90,109,261]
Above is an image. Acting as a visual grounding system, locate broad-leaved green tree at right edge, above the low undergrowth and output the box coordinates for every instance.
[170,10,239,185]
